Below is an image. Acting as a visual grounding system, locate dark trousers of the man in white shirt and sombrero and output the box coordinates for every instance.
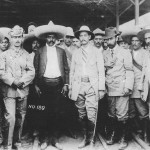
[39,77,63,134]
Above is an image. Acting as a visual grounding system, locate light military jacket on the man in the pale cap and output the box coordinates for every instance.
[0,49,35,98]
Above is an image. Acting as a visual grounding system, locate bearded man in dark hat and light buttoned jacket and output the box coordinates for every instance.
[103,27,134,148]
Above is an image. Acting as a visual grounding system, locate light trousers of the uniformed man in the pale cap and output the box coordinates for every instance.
[4,97,27,146]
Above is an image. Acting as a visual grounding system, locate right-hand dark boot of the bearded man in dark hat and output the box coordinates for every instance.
[119,121,128,150]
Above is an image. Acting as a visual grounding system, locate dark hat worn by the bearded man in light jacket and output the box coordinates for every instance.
[103,27,121,39]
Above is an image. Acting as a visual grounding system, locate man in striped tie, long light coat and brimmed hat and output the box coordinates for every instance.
[69,26,105,148]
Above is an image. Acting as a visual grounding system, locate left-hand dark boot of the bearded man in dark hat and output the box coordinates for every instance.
[106,118,116,145]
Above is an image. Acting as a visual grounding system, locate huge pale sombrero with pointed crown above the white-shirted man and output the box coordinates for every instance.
[34,21,66,39]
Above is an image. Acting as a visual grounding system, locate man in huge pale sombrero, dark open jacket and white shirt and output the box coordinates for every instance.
[34,22,69,149]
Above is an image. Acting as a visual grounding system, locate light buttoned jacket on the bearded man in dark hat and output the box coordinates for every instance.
[103,45,134,96]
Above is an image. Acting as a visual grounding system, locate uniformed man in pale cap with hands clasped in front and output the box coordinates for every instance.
[0,25,35,150]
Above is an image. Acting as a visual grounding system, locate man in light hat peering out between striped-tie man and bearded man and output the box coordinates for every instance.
[93,28,105,52]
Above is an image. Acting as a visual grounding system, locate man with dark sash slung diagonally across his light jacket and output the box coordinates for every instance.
[129,35,148,142]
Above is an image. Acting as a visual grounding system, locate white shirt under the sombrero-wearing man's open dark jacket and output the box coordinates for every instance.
[44,44,61,78]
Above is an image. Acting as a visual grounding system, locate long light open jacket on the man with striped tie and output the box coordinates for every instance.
[70,45,105,101]
